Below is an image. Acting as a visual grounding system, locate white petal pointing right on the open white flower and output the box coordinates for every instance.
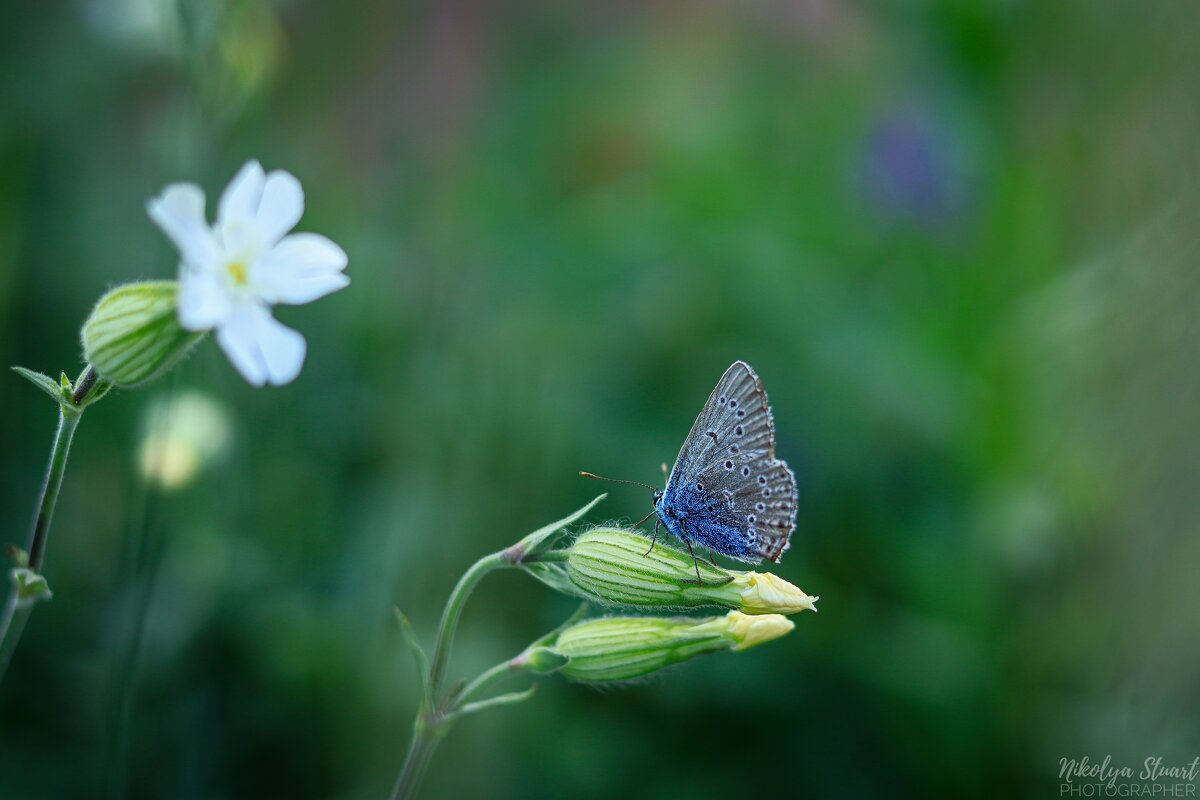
[250,234,350,305]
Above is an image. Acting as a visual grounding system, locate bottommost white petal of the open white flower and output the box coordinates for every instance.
[217,305,305,386]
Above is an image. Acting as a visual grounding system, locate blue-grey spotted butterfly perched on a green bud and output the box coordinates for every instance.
[588,361,797,582]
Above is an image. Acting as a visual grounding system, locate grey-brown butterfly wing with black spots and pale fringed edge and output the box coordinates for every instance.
[667,361,797,561]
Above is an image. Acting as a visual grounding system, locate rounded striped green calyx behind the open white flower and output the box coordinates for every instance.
[82,281,204,386]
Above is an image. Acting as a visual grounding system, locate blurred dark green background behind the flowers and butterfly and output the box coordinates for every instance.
[0,0,1200,799]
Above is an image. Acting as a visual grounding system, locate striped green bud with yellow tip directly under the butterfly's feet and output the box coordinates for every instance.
[566,529,816,614]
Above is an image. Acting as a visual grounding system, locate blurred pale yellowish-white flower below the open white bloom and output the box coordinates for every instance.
[138,391,229,489]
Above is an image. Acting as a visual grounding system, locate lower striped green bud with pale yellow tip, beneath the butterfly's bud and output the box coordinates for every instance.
[547,612,794,684]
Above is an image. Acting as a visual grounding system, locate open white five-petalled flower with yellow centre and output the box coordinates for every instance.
[146,161,350,386]
